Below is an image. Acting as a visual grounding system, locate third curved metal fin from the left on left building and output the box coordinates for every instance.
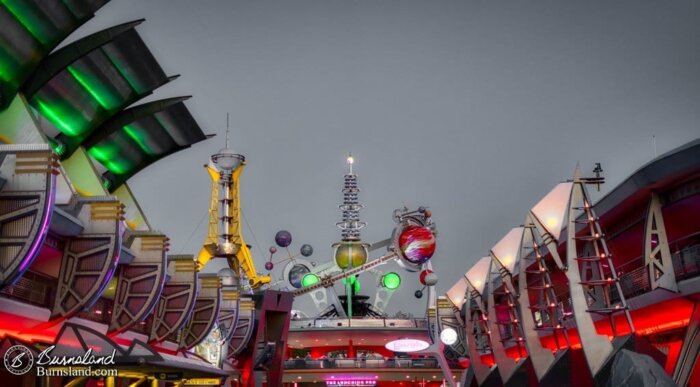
[107,231,168,334]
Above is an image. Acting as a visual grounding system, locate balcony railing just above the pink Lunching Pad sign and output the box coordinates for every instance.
[284,358,440,369]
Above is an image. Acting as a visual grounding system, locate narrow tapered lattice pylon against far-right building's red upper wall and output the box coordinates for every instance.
[644,192,678,292]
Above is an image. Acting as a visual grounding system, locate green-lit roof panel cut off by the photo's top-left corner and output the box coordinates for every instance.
[0,0,109,110]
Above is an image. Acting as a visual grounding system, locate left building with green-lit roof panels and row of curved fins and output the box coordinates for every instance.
[0,0,243,386]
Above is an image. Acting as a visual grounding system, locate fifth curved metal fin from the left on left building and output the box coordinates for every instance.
[178,274,221,350]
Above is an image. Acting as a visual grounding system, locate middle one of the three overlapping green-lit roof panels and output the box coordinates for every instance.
[23,20,172,158]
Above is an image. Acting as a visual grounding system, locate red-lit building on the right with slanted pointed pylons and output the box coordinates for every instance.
[438,140,700,386]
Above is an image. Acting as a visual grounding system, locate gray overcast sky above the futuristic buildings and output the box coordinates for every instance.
[71,0,700,315]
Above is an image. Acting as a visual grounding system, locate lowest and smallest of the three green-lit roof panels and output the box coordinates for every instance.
[83,97,209,192]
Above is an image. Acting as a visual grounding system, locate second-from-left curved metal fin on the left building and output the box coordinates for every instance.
[50,196,124,321]
